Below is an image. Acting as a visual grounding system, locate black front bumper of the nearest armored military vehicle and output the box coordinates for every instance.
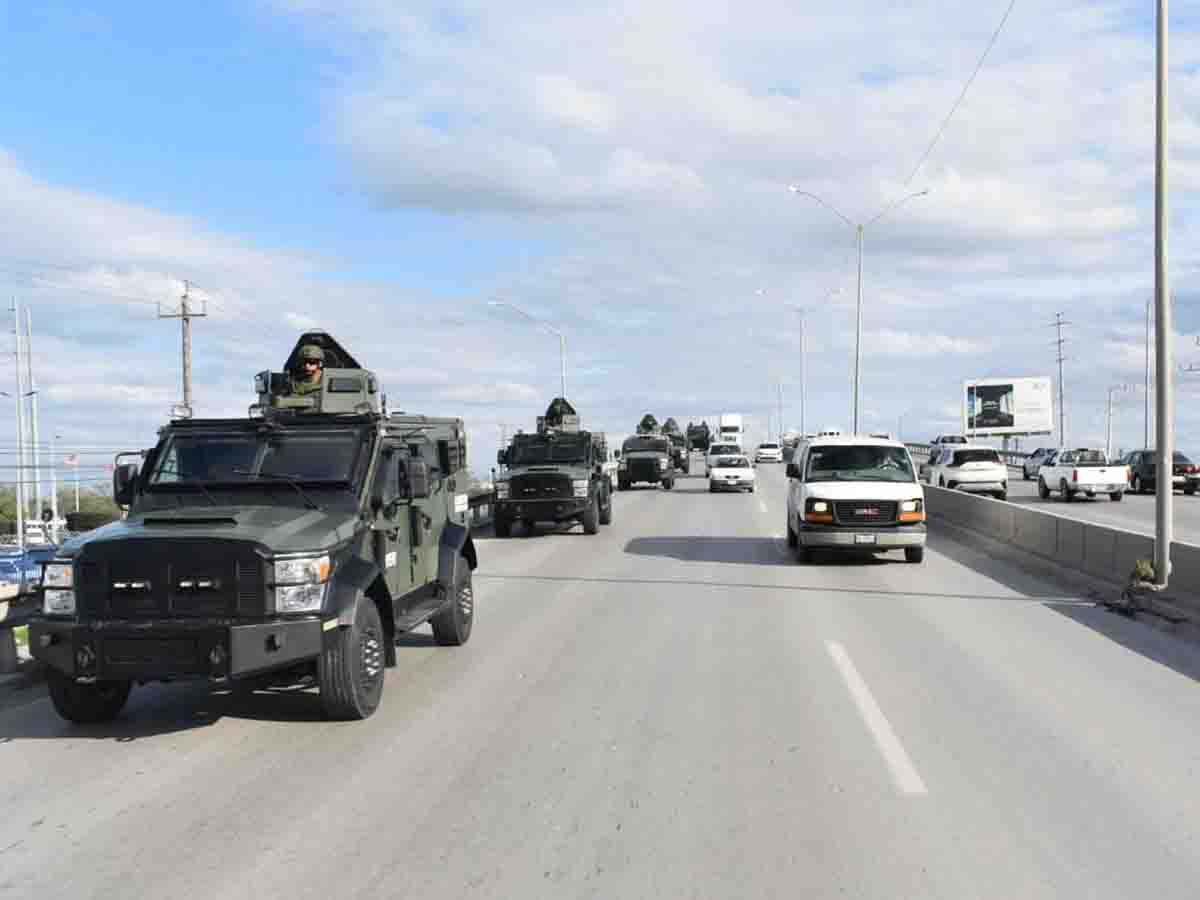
[29,617,336,680]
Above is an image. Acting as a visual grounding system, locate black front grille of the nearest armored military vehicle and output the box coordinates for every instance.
[76,539,266,619]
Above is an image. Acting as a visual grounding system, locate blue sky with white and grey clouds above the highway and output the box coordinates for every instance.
[0,0,1200,489]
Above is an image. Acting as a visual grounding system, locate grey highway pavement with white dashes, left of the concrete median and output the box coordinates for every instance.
[0,467,1200,900]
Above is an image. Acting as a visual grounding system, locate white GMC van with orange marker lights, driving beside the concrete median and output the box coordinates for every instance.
[787,437,925,563]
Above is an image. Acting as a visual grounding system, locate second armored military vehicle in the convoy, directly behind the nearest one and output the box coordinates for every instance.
[492,397,612,538]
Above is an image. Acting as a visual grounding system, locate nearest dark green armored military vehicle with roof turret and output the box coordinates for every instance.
[30,331,476,722]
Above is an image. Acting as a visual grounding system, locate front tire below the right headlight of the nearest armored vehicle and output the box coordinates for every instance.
[317,595,386,719]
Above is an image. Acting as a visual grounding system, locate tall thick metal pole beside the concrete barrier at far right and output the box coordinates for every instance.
[1154,0,1175,588]
